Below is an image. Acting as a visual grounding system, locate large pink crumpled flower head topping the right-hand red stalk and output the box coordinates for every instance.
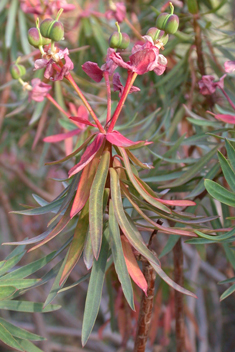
[110,35,167,76]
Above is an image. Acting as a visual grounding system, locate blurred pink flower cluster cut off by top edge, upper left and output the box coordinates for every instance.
[20,0,75,15]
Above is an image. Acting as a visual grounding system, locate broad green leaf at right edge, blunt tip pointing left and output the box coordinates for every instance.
[205,180,235,207]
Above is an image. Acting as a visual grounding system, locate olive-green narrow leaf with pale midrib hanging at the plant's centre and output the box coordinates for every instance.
[89,151,110,260]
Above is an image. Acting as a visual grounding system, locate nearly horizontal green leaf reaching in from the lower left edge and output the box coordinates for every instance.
[0,300,60,313]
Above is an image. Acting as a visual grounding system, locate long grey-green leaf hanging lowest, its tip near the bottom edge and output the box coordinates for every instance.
[82,229,109,346]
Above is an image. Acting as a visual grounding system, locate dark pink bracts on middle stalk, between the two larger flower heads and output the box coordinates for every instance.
[82,48,118,83]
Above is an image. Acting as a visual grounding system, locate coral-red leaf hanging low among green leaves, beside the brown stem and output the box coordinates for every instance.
[121,236,148,294]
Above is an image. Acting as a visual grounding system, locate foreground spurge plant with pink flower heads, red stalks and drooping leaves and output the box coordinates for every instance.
[0,2,235,351]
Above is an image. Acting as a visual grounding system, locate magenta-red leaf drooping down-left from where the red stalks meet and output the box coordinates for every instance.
[69,133,105,177]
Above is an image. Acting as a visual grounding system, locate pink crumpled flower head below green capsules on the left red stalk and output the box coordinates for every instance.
[34,48,74,81]
